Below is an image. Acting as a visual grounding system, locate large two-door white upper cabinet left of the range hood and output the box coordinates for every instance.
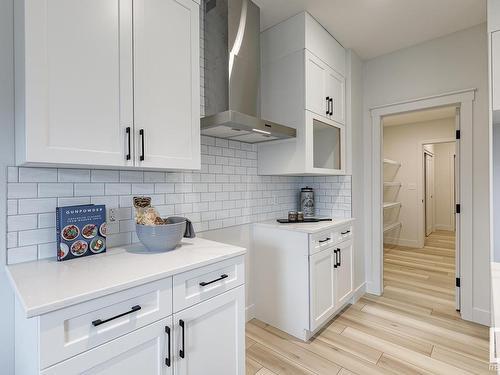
[15,0,200,169]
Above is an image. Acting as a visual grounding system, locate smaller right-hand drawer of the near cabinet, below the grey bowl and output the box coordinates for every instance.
[174,256,245,312]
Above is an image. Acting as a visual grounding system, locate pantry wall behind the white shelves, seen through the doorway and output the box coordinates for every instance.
[384,118,455,247]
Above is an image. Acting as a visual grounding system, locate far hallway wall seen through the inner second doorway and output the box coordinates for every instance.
[434,142,455,231]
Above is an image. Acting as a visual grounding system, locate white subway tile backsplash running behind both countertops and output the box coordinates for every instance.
[7,136,351,263]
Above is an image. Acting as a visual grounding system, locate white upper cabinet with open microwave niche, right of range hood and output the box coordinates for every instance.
[258,13,350,175]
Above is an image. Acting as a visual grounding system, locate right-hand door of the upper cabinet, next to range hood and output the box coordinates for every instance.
[133,0,200,169]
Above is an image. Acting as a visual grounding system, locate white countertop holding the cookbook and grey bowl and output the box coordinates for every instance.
[6,238,246,318]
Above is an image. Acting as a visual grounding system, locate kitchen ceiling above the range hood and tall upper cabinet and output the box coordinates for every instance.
[253,0,486,60]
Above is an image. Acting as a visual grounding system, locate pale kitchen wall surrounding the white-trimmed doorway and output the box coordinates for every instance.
[364,24,490,322]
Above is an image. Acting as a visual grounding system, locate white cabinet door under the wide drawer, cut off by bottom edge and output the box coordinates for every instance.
[41,317,173,375]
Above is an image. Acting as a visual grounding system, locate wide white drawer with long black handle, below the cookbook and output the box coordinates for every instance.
[40,277,172,369]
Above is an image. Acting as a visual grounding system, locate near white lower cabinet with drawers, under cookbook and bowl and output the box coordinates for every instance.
[18,256,245,375]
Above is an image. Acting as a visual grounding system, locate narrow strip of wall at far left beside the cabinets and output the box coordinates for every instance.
[0,0,14,375]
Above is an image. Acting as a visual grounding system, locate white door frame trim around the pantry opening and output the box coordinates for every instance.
[367,89,476,320]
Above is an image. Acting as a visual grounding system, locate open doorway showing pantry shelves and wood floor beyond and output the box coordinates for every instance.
[381,105,460,315]
